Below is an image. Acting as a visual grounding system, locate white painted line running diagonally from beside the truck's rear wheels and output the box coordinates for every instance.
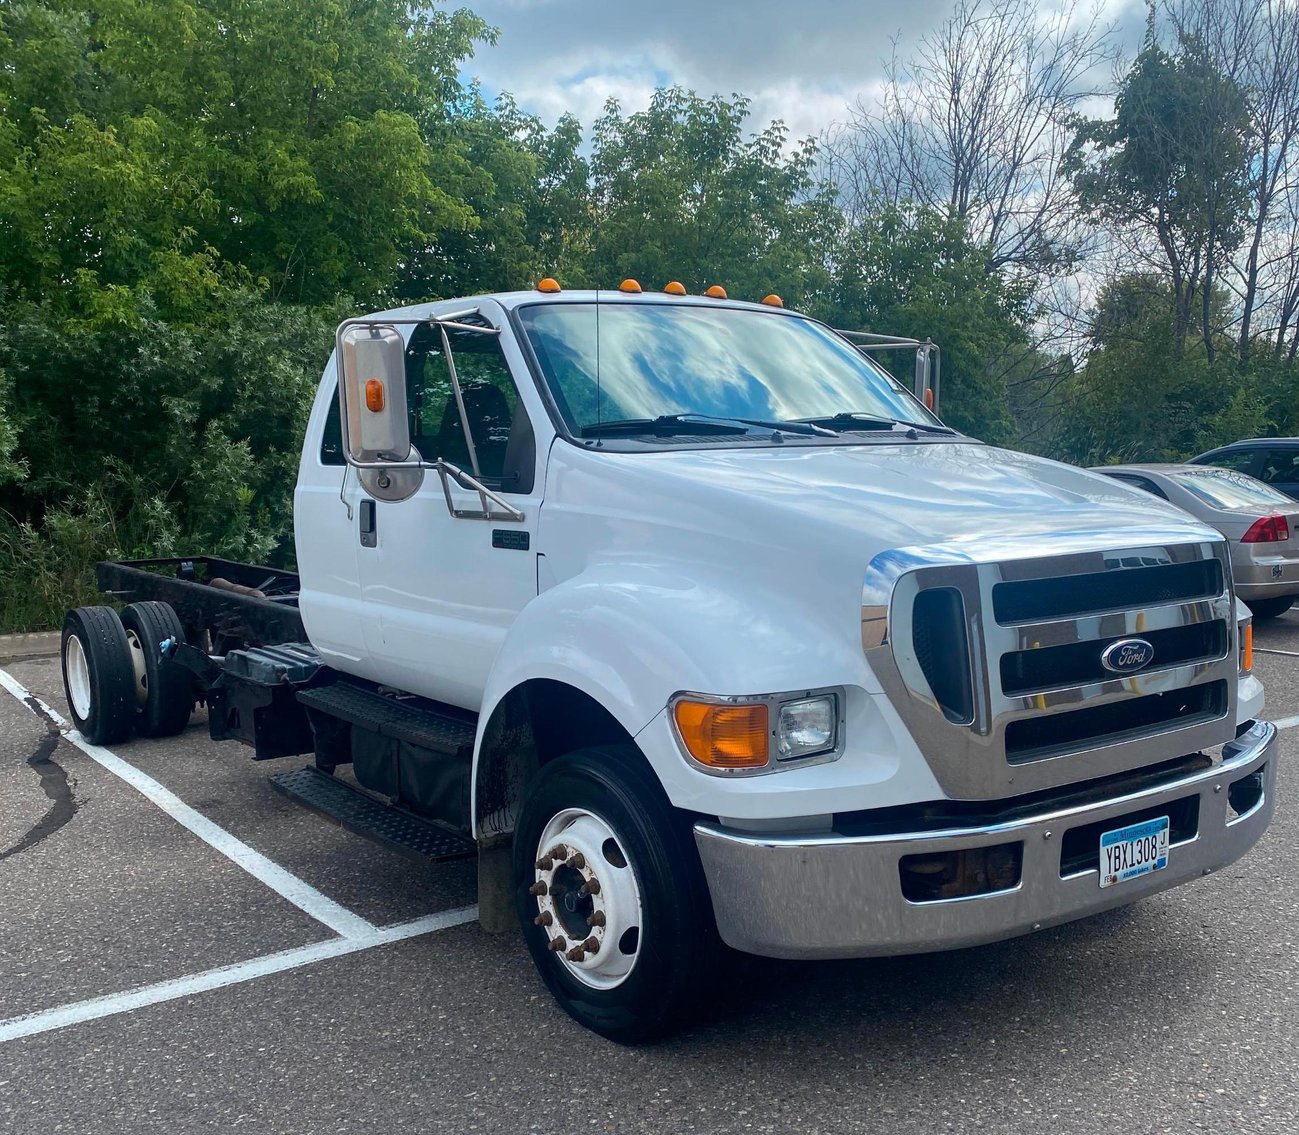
[0,670,378,940]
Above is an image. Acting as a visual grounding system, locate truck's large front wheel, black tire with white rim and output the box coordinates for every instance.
[514,745,720,1044]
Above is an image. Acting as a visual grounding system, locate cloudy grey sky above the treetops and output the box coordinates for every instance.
[464,0,1144,138]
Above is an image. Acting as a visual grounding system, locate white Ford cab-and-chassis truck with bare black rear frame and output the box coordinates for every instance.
[62,281,1276,1041]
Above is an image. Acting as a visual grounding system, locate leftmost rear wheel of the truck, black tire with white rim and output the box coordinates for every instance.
[60,606,135,745]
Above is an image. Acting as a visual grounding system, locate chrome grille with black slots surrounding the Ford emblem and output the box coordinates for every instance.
[863,536,1237,799]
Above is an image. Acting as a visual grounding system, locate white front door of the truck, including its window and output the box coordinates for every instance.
[357,309,543,709]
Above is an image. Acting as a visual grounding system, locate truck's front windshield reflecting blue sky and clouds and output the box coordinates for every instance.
[520,301,938,434]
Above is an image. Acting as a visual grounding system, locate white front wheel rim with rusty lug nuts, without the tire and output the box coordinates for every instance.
[531,808,644,990]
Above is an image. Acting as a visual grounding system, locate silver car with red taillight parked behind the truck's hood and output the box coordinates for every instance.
[1092,465,1299,619]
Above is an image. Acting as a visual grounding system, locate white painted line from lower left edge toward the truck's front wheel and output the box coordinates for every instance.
[0,906,478,1044]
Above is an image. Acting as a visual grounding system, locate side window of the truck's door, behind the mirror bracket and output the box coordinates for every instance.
[407,325,536,492]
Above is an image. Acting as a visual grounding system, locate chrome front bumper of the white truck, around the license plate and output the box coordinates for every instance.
[695,722,1277,958]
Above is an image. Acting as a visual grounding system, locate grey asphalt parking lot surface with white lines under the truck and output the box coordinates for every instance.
[0,610,1299,1135]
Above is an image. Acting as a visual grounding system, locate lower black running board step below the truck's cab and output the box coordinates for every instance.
[270,766,478,860]
